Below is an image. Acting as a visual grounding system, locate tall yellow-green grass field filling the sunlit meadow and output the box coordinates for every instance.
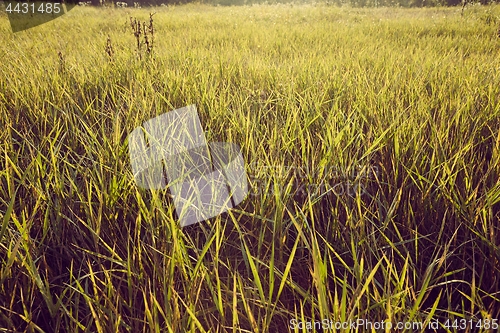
[0,5,500,332]
